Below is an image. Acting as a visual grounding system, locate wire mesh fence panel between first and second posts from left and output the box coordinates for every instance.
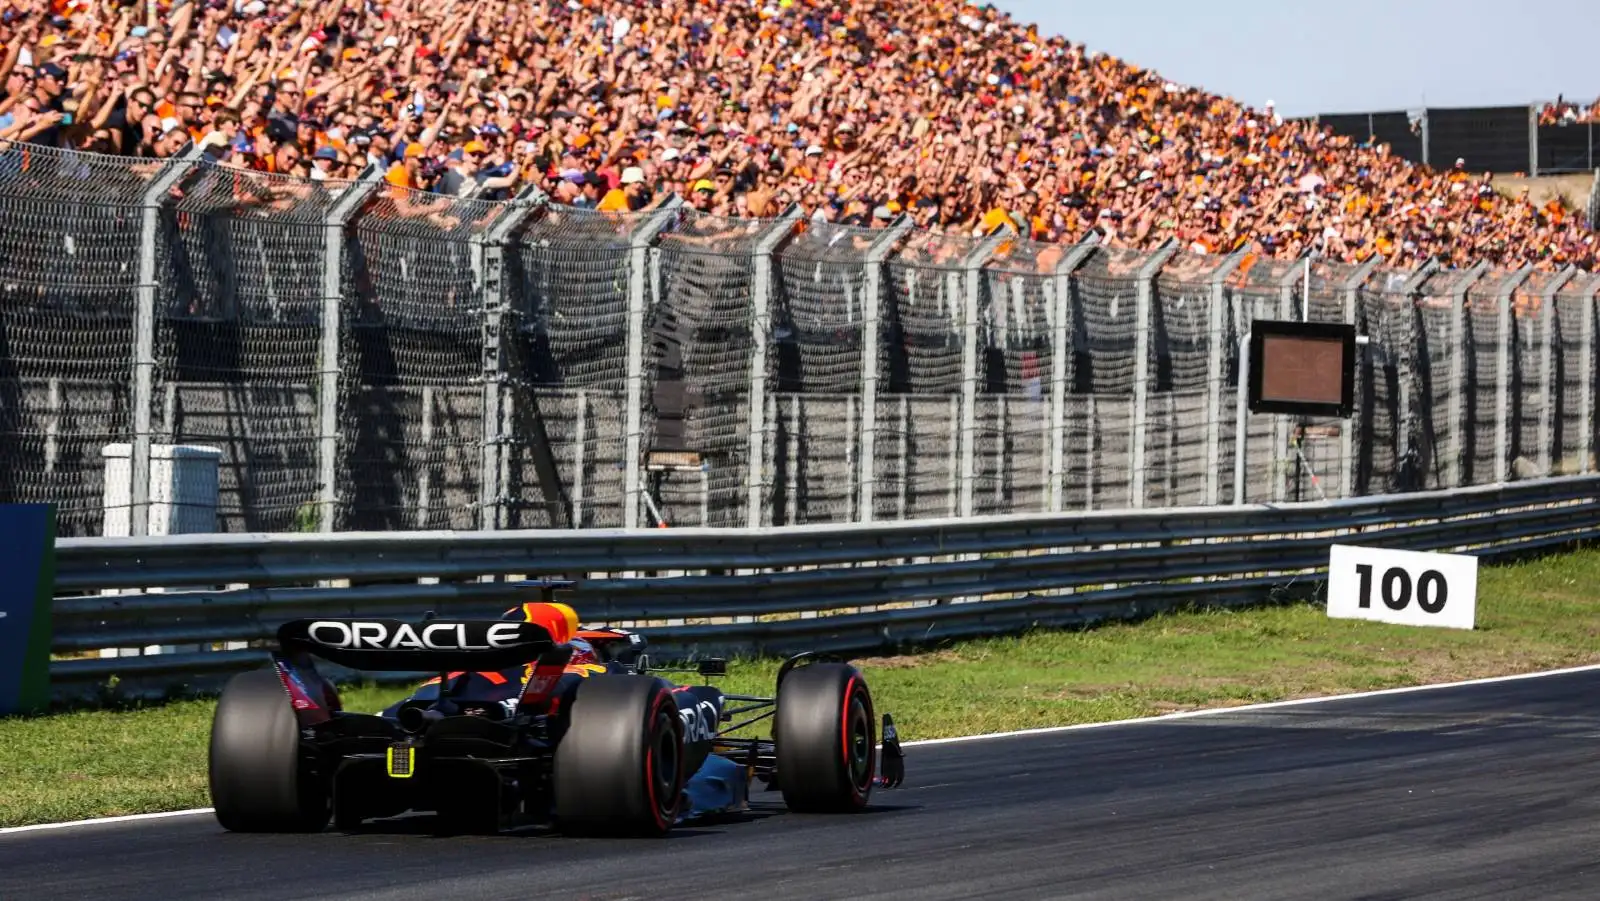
[152,165,349,531]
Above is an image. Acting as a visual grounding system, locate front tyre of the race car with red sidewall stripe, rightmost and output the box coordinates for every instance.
[773,663,877,813]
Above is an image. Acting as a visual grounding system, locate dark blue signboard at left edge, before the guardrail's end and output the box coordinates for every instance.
[0,504,56,715]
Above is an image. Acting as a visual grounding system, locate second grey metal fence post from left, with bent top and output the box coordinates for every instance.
[317,165,384,531]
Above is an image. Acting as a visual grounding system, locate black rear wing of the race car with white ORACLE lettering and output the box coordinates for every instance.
[278,619,570,672]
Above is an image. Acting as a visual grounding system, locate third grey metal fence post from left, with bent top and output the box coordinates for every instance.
[472,186,546,530]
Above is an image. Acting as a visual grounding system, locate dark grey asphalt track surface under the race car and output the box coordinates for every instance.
[0,672,1600,901]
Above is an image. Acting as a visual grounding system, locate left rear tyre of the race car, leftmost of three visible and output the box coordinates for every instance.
[210,669,333,832]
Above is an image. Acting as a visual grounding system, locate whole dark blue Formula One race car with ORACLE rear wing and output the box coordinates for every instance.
[210,581,904,835]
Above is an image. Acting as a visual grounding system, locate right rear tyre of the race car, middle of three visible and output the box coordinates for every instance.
[552,675,685,835]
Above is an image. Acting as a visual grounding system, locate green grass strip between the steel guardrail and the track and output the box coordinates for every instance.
[0,551,1600,826]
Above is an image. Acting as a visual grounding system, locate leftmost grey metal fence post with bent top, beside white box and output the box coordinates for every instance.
[128,144,202,536]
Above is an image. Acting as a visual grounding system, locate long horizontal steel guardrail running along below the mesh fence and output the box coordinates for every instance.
[51,475,1600,696]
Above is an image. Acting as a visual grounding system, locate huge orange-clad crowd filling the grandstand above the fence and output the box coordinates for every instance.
[0,0,1595,266]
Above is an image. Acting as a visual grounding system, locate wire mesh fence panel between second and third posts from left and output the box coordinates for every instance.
[339,184,506,531]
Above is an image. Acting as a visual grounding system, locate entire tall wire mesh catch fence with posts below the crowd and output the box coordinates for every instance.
[0,146,1600,536]
